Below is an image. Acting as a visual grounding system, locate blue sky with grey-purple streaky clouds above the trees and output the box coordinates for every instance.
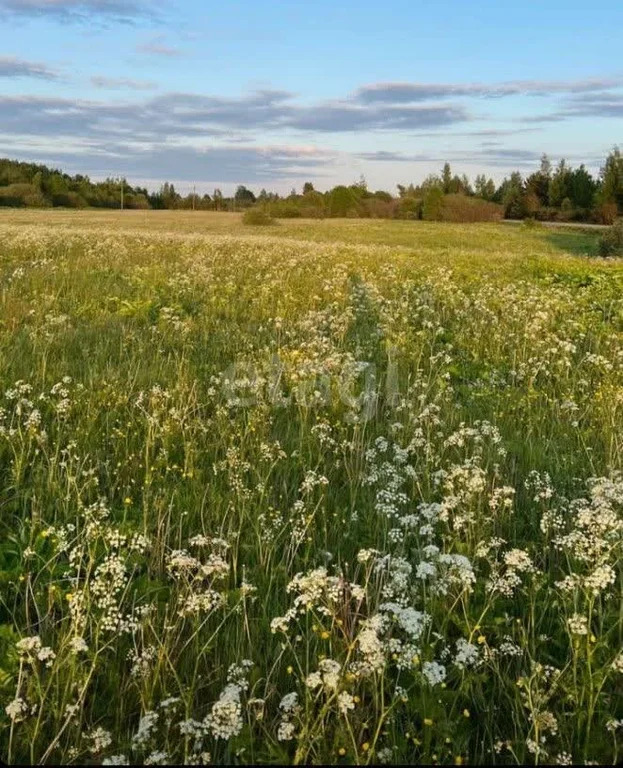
[0,0,623,194]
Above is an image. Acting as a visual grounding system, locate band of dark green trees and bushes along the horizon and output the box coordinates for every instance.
[0,147,623,224]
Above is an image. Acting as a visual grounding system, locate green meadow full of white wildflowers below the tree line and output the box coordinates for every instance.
[0,210,623,764]
